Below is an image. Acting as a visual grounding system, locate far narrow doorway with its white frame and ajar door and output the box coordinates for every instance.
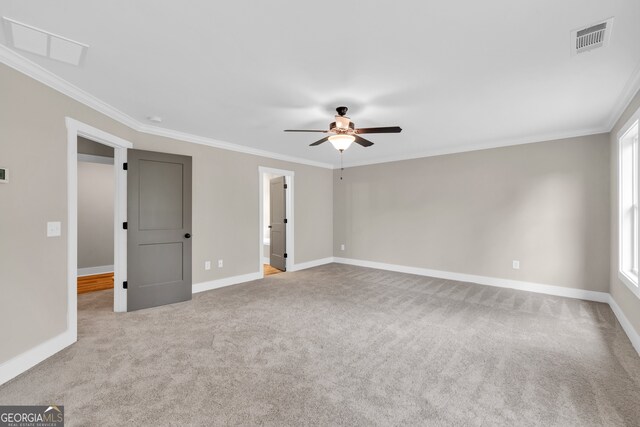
[259,167,294,277]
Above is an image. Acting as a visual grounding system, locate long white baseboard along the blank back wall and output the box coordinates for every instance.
[334,257,609,302]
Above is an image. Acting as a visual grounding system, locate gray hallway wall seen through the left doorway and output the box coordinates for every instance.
[78,160,115,268]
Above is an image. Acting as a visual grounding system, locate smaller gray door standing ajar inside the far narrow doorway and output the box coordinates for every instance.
[269,176,287,271]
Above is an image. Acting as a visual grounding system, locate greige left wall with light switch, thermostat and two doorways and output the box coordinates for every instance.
[0,65,333,363]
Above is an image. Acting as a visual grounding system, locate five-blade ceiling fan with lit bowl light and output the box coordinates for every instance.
[285,107,402,153]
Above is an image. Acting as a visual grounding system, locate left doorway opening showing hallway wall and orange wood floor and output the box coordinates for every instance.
[77,136,115,295]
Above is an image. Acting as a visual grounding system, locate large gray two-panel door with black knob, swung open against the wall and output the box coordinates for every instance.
[127,150,192,311]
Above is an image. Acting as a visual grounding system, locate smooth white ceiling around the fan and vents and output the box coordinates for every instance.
[0,0,640,165]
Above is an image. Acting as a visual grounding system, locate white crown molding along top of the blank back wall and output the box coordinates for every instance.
[334,126,610,169]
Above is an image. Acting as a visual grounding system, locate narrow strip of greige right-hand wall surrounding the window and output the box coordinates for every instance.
[610,92,640,334]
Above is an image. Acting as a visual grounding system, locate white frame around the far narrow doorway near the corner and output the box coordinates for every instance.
[258,166,295,278]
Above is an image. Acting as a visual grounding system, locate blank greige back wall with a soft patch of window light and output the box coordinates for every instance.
[333,134,610,292]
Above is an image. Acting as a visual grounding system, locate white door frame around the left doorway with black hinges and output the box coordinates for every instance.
[65,117,133,334]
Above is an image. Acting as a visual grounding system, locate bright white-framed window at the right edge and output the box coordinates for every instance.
[618,110,640,296]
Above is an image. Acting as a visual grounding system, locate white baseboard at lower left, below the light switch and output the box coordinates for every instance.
[0,330,76,385]
